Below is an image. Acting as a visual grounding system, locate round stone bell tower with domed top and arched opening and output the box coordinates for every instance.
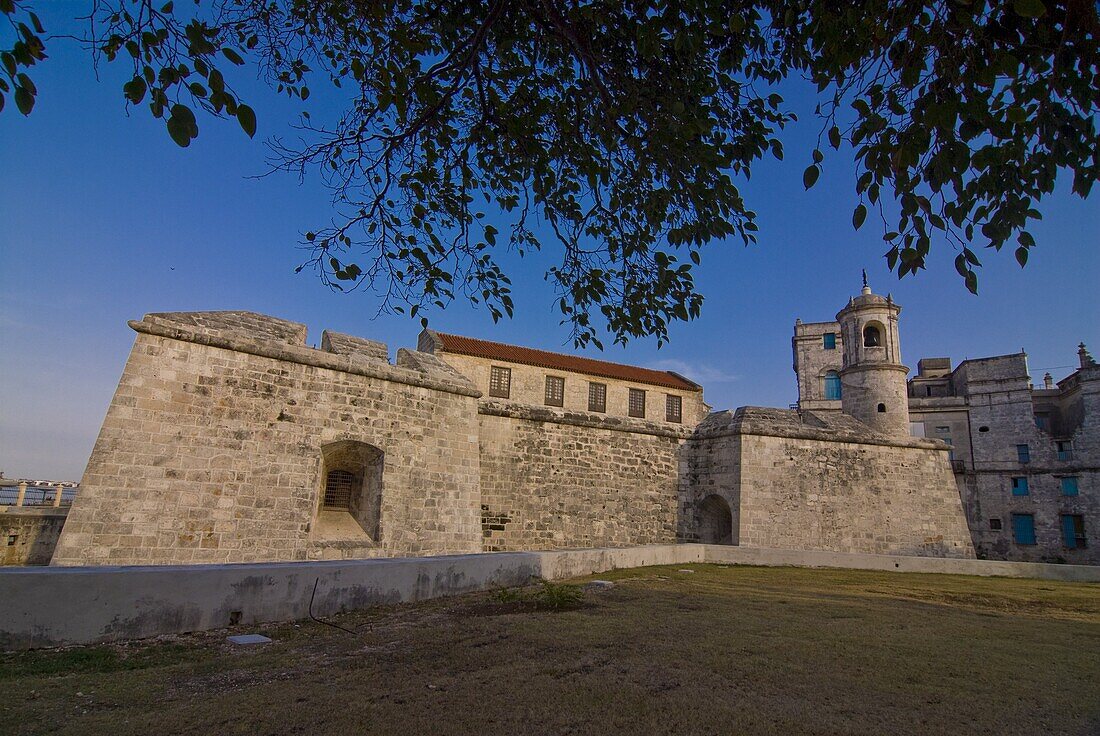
[836,274,909,437]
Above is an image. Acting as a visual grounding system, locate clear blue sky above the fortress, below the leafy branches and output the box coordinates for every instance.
[0,2,1100,480]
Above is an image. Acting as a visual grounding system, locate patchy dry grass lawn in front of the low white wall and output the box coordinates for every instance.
[0,564,1100,736]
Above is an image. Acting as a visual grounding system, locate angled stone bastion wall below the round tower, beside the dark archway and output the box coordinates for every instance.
[681,407,974,557]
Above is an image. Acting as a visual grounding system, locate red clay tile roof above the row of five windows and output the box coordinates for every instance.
[424,332,703,391]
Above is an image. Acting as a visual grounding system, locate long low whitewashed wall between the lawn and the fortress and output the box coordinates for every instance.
[0,545,1100,649]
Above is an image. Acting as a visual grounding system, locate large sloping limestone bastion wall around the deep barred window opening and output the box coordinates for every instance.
[53,312,481,564]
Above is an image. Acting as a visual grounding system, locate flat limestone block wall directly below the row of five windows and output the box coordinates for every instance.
[480,400,688,551]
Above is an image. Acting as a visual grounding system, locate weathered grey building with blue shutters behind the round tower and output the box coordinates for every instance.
[792,308,1100,564]
